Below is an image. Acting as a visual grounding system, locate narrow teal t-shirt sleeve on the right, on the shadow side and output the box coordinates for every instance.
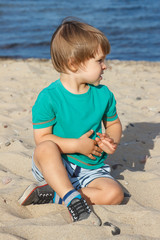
[103,89,118,121]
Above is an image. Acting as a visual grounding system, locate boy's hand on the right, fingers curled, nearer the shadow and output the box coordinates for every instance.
[95,133,117,154]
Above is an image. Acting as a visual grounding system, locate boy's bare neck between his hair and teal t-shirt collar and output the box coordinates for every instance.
[60,73,89,94]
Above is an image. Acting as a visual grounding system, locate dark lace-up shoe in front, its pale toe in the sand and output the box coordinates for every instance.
[68,198,101,226]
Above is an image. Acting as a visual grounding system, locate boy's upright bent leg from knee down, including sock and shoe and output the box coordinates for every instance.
[34,141,101,226]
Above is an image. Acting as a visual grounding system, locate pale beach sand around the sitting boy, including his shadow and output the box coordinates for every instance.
[0,59,160,240]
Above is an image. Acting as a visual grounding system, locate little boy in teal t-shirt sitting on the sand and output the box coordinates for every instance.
[19,19,124,225]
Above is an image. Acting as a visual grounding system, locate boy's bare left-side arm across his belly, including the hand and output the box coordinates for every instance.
[34,126,101,159]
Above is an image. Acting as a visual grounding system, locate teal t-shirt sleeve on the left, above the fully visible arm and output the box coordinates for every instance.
[32,91,56,129]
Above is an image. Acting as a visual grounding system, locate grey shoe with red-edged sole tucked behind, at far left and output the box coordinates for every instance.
[18,181,54,206]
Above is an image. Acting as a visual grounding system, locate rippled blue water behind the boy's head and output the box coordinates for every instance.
[0,0,160,61]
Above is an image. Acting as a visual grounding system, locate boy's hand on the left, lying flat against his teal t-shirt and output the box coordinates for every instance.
[78,130,102,160]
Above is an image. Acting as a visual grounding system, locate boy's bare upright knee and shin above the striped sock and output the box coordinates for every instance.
[34,141,74,198]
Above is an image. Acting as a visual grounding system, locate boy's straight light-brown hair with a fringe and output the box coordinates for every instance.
[50,19,110,73]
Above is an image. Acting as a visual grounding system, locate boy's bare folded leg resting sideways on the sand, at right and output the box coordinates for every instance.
[79,178,124,205]
